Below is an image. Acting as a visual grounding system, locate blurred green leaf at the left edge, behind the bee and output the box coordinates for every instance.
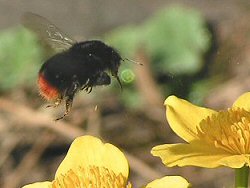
[0,27,43,91]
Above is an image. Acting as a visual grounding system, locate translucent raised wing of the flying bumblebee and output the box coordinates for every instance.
[22,12,76,52]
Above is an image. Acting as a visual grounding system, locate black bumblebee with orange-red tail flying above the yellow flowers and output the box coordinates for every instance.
[22,12,124,120]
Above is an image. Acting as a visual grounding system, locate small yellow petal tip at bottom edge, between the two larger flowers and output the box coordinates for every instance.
[146,176,190,188]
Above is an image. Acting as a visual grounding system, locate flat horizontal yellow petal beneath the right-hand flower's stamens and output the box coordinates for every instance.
[151,141,248,168]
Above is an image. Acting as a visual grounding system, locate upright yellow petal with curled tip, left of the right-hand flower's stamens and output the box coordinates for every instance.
[164,96,216,142]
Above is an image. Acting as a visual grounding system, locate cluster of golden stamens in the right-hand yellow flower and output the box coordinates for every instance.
[197,108,250,154]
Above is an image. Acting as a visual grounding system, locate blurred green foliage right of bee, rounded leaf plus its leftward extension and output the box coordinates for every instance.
[106,6,210,75]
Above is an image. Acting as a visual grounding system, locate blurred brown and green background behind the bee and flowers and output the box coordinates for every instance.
[0,0,250,188]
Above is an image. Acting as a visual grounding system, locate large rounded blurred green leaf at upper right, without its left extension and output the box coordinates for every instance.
[143,7,210,75]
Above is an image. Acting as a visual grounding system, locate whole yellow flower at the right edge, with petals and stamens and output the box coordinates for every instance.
[151,93,250,168]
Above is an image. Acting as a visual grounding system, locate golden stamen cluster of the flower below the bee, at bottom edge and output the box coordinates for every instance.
[51,166,131,188]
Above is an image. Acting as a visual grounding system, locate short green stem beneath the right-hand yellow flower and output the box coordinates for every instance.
[235,166,249,188]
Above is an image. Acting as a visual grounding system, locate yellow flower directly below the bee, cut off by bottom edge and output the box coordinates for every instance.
[23,136,131,188]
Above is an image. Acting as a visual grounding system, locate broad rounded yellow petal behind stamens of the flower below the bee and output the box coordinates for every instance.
[56,136,129,178]
